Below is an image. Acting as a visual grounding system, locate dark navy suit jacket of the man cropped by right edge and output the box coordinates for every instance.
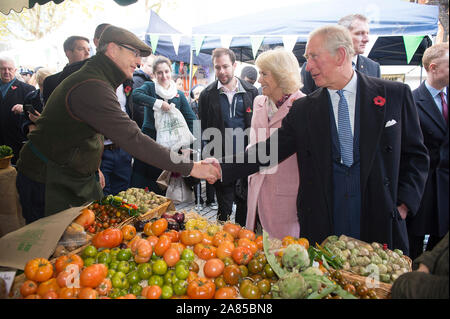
[407,82,449,237]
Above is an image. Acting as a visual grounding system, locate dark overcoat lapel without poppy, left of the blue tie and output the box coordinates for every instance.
[303,88,334,221]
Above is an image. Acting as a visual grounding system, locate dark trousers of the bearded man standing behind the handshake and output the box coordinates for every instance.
[214,182,247,226]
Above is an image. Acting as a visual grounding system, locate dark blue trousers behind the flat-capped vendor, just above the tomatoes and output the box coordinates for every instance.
[100,148,133,196]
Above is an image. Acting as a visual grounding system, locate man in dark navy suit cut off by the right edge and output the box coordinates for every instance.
[406,43,449,259]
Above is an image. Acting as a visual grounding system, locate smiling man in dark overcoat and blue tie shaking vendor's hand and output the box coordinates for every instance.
[214,25,428,254]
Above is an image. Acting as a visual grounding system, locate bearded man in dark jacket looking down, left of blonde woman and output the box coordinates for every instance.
[199,48,258,226]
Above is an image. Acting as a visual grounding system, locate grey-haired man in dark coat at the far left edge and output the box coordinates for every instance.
[0,57,36,164]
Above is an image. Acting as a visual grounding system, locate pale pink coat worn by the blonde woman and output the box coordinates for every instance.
[246,91,304,239]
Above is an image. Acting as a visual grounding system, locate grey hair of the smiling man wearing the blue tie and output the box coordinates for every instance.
[309,25,355,60]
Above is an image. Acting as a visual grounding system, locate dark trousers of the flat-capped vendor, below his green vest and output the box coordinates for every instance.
[16,172,45,224]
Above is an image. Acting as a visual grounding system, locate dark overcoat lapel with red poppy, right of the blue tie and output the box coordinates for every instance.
[355,72,389,196]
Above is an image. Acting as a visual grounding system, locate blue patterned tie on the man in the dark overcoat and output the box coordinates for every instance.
[337,90,353,167]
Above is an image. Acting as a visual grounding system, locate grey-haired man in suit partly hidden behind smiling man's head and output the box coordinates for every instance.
[301,14,381,94]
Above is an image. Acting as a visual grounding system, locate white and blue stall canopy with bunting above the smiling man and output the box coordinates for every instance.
[192,0,439,65]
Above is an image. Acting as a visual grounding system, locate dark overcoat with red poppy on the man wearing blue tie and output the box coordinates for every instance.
[221,72,429,250]
